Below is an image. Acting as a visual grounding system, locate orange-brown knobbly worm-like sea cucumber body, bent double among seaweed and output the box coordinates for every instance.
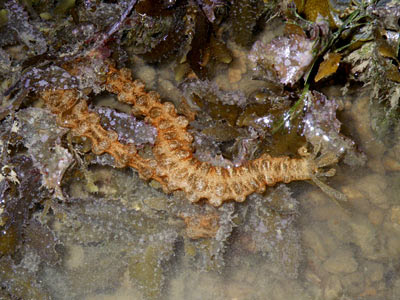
[41,66,332,206]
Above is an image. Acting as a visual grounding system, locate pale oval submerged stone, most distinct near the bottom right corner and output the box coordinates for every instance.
[323,249,358,274]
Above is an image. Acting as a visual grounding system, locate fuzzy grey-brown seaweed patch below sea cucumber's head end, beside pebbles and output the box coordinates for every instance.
[234,185,302,278]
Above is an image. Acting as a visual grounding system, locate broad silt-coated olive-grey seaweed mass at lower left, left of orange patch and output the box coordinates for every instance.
[43,193,177,299]
